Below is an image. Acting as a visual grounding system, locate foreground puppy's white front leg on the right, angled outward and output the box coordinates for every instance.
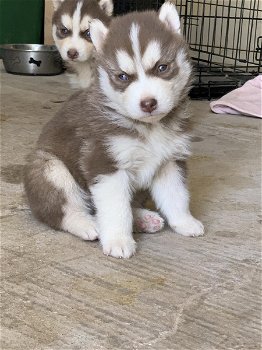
[151,162,204,236]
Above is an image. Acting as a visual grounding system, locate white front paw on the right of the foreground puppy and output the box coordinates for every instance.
[171,215,204,237]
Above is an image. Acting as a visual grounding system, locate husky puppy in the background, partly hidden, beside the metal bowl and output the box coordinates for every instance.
[52,0,113,88]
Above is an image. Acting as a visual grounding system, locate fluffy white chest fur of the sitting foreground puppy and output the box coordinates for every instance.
[107,129,189,189]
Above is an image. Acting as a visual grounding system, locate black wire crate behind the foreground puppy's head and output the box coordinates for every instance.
[115,0,262,99]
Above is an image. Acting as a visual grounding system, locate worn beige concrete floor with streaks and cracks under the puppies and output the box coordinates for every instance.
[1,63,262,350]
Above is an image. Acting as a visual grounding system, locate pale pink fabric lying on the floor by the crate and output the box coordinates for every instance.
[210,75,262,118]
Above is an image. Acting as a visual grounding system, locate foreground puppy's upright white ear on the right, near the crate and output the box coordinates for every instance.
[158,2,181,34]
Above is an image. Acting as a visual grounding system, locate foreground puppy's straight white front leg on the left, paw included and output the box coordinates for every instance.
[90,170,136,258]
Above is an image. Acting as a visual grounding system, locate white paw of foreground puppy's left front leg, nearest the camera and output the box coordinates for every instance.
[102,237,136,258]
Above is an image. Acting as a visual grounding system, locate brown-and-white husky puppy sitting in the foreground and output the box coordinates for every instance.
[25,2,204,258]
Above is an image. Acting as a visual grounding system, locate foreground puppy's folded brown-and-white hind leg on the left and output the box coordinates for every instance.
[25,151,97,240]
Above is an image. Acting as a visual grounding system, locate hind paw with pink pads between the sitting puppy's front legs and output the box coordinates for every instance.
[133,208,165,233]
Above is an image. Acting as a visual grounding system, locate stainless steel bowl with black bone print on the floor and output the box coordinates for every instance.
[0,44,63,75]
